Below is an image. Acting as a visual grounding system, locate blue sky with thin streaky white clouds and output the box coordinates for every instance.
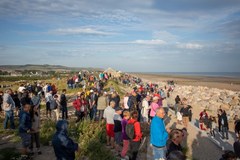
[0,0,240,72]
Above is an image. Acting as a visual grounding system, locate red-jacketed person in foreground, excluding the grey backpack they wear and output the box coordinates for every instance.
[128,111,142,160]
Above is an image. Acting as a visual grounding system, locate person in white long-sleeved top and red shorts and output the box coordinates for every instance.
[103,101,115,149]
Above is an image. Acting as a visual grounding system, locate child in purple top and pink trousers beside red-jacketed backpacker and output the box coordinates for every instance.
[121,110,130,158]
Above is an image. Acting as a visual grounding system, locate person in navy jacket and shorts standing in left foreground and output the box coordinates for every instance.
[19,104,32,158]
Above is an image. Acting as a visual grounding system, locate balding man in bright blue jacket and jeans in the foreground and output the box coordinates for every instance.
[150,108,168,159]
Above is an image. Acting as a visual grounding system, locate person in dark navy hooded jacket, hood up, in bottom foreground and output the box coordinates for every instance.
[52,120,78,160]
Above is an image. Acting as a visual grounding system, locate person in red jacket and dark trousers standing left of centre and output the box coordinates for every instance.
[73,93,87,123]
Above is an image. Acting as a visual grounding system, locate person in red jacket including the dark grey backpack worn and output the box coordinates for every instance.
[126,111,142,160]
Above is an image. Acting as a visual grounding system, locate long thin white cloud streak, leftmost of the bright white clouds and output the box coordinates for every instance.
[49,28,116,36]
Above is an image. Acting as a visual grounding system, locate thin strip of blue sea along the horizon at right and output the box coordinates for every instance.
[142,72,240,78]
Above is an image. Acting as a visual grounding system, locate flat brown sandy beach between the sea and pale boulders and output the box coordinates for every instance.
[131,73,240,91]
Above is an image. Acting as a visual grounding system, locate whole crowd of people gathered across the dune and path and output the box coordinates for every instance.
[0,73,240,160]
